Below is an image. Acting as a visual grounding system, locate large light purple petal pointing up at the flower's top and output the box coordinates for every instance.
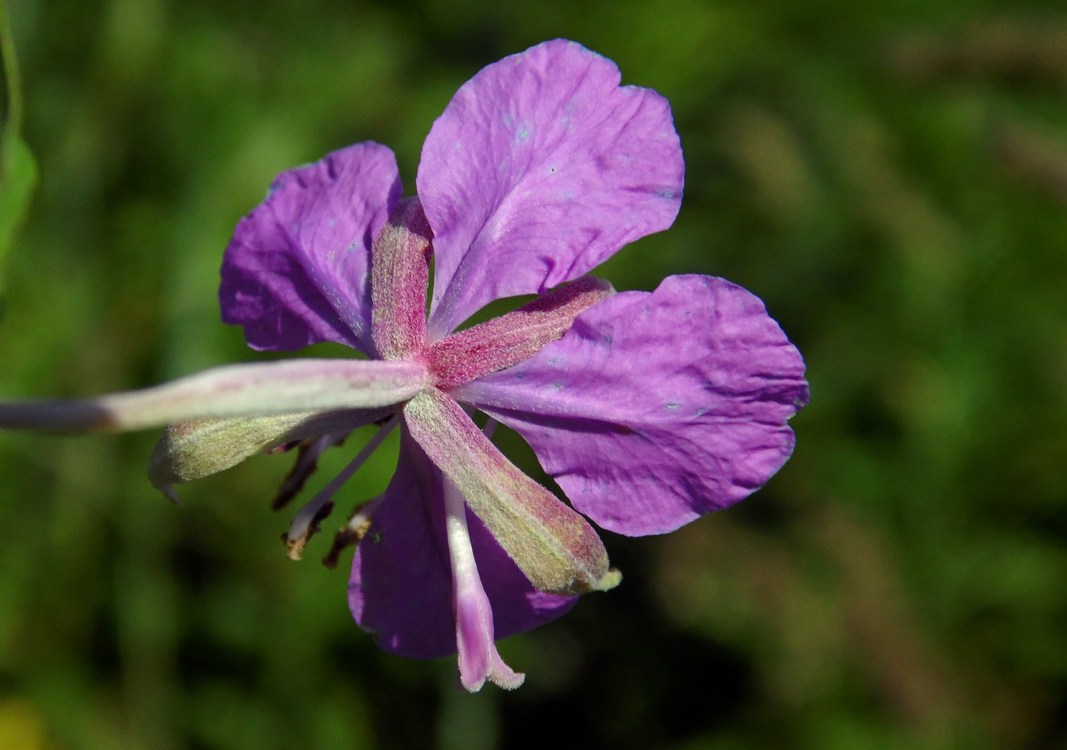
[417,39,684,337]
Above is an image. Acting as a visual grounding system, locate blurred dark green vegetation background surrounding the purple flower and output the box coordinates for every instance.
[0,0,1067,750]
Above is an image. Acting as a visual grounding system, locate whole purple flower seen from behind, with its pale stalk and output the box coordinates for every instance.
[0,41,808,690]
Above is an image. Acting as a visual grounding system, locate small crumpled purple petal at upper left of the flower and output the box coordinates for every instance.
[219,143,401,353]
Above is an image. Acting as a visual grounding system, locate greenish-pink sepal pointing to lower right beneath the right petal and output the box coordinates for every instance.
[403,388,621,594]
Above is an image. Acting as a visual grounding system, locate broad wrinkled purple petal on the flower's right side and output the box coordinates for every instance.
[453,275,808,536]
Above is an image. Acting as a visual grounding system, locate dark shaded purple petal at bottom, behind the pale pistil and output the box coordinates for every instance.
[348,432,577,658]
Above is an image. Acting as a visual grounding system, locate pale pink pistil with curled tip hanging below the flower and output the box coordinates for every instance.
[445,479,526,692]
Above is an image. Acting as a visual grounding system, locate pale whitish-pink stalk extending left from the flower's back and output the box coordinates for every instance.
[0,358,429,431]
